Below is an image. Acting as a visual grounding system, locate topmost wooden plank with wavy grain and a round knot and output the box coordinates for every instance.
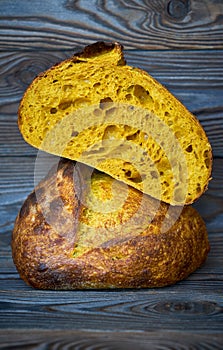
[0,0,223,49]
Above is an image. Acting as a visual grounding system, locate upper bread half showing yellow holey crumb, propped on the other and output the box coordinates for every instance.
[18,42,212,205]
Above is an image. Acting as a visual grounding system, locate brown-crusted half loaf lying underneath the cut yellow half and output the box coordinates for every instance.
[12,159,209,289]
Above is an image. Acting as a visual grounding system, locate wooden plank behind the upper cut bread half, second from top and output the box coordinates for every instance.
[0,50,223,156]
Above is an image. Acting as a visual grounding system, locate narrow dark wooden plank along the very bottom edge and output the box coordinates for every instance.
[0,330,222,350]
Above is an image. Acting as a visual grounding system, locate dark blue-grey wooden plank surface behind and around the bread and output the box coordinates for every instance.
[0,0,223,350]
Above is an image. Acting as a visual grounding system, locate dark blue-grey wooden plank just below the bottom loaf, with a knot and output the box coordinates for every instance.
[0,280,223,334]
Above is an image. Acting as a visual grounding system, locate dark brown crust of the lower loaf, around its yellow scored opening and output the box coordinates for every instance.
[12,160,209,289]
